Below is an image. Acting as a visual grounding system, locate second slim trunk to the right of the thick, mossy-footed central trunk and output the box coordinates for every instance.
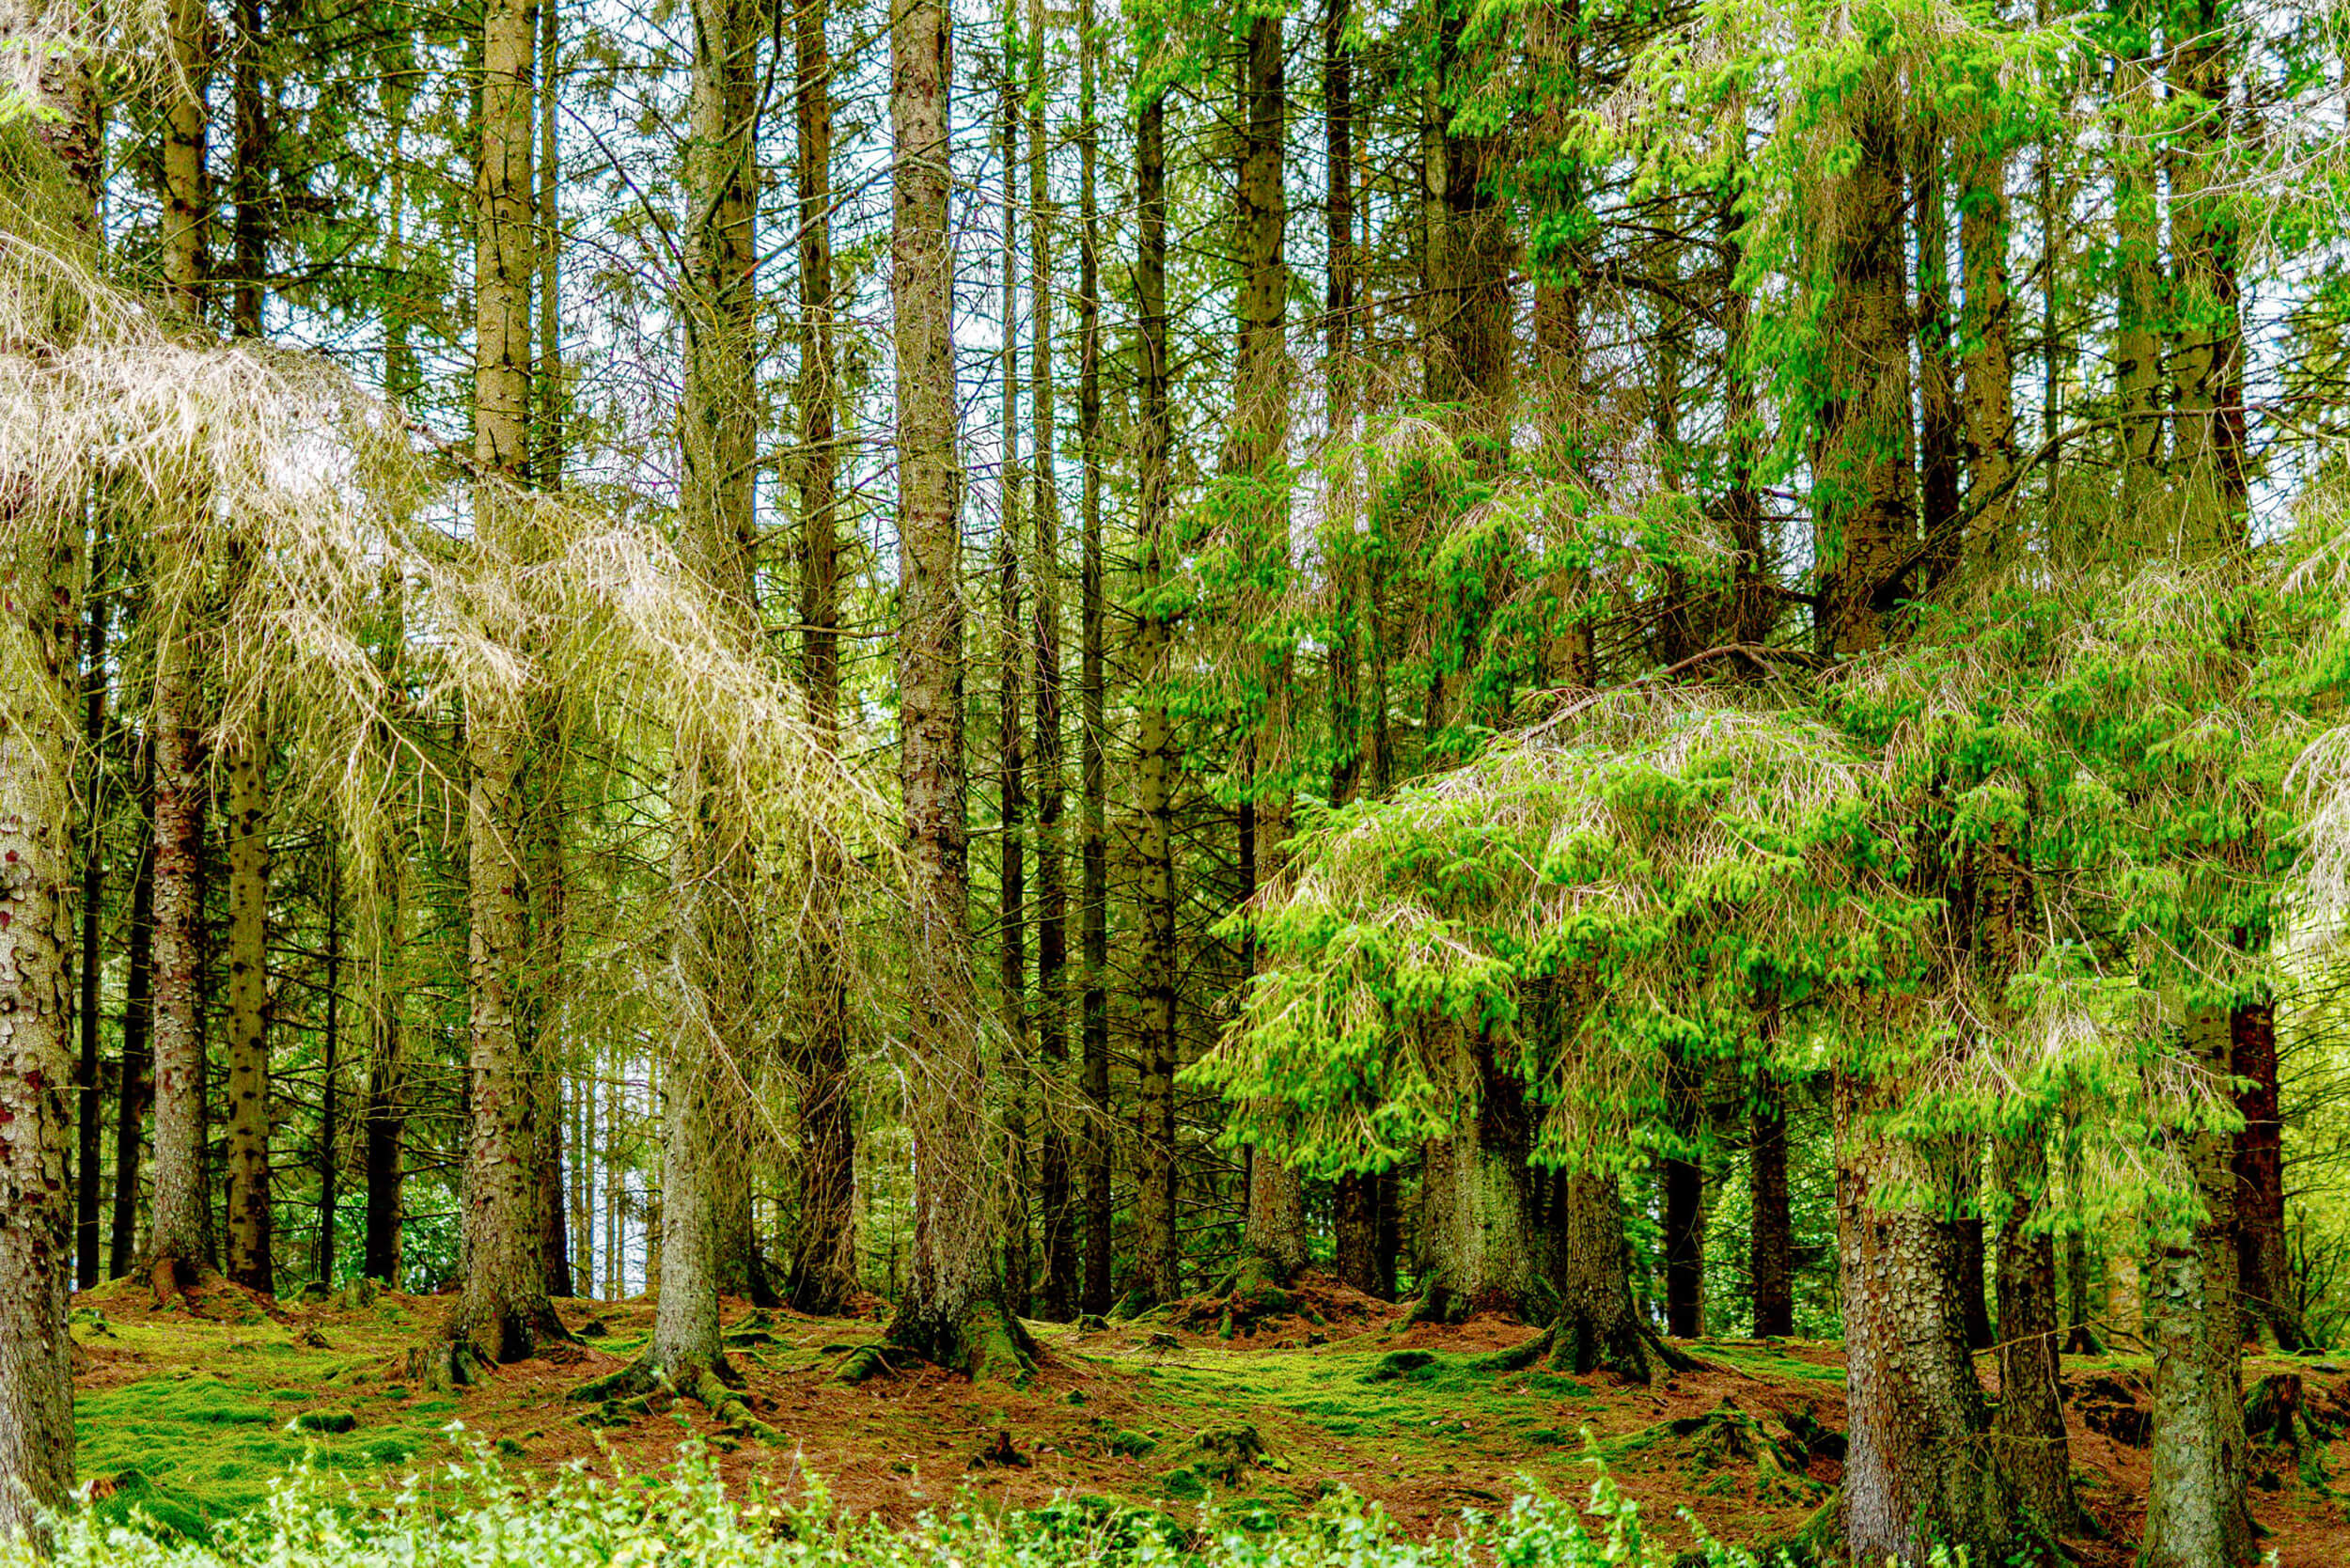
[1027,0,1076,1324]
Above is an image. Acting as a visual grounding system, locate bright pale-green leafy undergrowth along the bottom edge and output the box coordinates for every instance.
[0,1434,1842,1568]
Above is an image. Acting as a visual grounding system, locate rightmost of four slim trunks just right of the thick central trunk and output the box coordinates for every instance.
[1136,92,1183,1300]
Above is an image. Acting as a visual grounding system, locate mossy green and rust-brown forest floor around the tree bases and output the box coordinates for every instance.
[59,1281,2350,1568]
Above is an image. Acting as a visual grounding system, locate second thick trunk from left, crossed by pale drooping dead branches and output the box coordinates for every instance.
[146,0,212,1297]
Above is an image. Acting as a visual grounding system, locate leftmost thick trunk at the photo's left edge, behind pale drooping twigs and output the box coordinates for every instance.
[0,0,102,1523]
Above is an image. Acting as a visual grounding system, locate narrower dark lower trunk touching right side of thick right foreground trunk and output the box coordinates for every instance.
[1991,1131,2094,1535]
